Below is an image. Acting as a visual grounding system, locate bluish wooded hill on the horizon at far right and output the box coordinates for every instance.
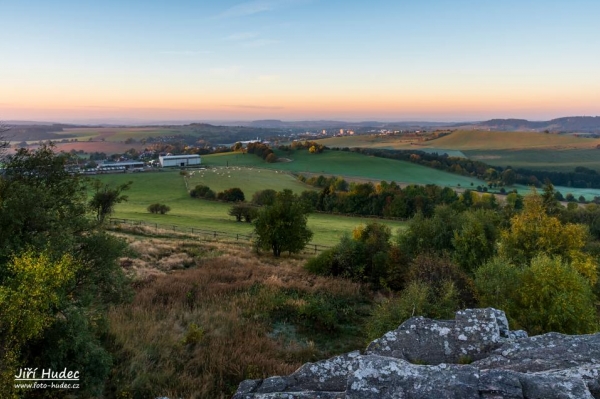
[452,116,600,133]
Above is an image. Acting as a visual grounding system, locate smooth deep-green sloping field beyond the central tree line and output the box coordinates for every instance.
[202,150,482,187]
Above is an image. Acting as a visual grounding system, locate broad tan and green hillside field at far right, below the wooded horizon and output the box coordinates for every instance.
[319,130,600,172]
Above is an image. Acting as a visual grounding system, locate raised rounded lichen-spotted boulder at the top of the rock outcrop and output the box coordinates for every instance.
[367,308,524,364]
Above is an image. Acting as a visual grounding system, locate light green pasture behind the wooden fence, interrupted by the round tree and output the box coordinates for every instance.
[99,170,405,245]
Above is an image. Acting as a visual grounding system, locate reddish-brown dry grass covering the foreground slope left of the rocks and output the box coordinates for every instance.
[107,233,364,398]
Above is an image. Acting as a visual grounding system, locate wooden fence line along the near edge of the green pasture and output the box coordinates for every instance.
[109,218,332,255]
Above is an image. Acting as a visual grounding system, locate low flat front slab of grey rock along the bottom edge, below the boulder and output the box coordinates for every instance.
[346,356,593,399]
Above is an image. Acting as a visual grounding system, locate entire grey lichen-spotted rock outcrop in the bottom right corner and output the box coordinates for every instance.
[233,308,600,399]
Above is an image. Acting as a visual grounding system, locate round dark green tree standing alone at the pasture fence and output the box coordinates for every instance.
[254,190,313,256]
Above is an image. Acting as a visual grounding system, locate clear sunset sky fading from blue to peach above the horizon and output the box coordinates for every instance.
[0,0,600,122]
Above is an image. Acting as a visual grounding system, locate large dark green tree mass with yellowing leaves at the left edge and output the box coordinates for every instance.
[0,145,130,396]
